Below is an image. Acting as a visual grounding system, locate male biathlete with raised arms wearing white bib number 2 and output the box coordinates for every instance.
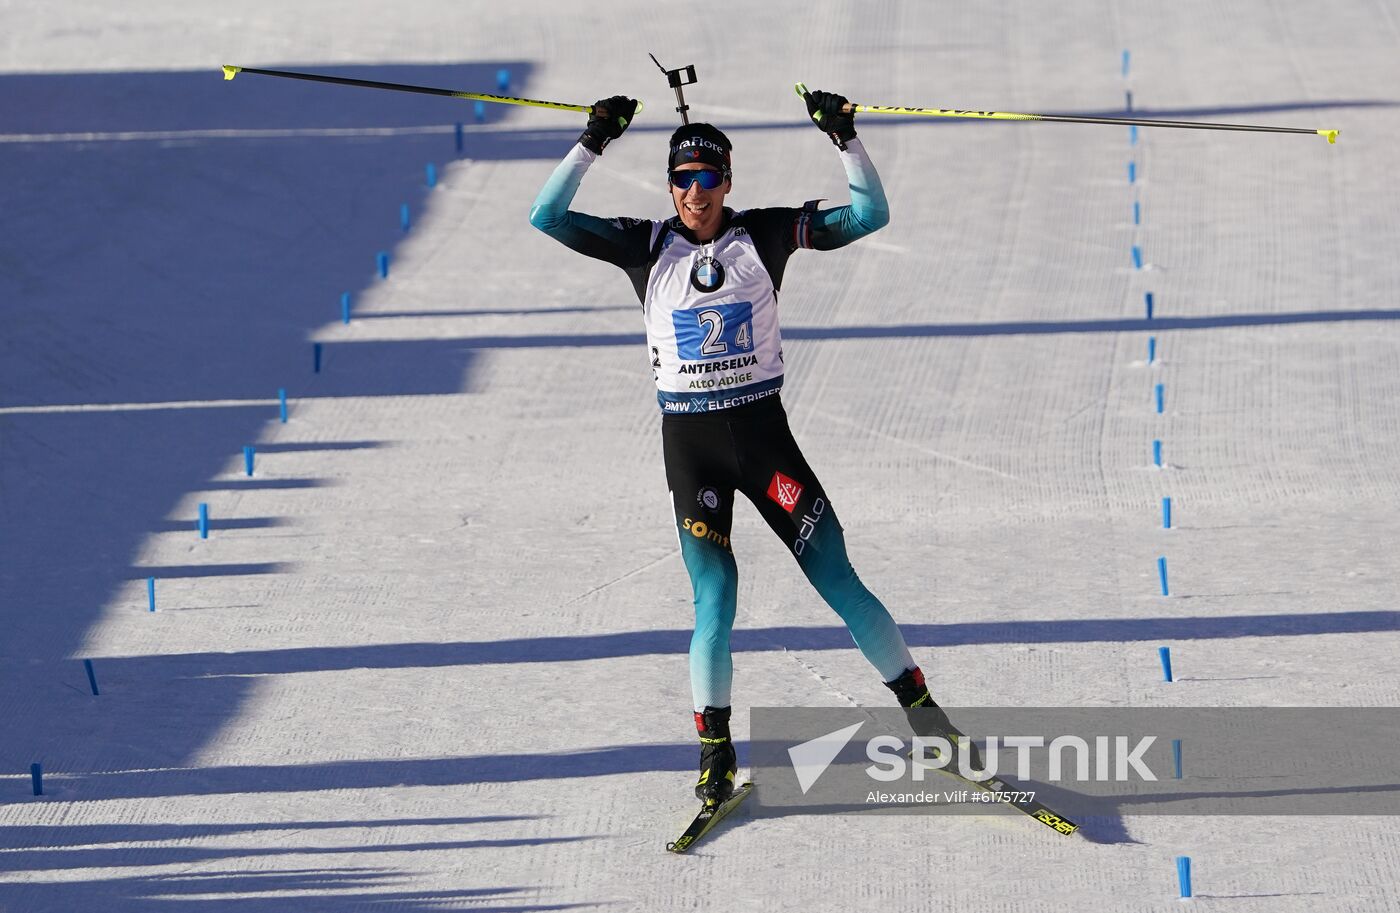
[531,92,960,805]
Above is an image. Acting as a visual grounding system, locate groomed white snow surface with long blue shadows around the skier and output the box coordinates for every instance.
[0,0,1400,913]
